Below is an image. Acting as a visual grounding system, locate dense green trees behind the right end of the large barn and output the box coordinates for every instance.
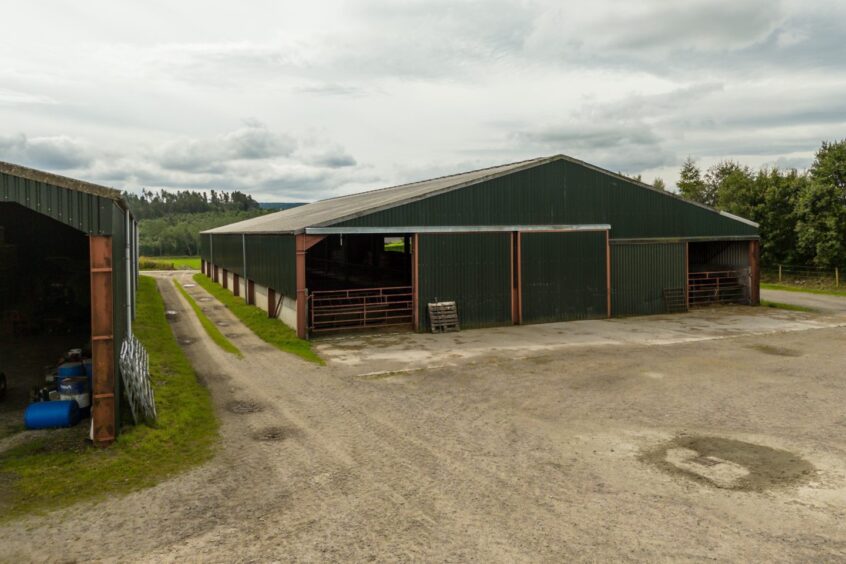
[677,140,846,268]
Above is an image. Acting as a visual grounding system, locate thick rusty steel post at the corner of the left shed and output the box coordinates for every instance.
[89,235,116,446]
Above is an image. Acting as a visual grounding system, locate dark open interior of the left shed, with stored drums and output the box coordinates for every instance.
[0,203,91,436]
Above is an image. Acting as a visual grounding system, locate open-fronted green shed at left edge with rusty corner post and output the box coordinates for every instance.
[0,162,138,446]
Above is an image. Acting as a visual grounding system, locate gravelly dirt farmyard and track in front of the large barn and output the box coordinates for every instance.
[0,274,846,562]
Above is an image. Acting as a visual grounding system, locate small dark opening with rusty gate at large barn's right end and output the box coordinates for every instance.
[688,241,751,307]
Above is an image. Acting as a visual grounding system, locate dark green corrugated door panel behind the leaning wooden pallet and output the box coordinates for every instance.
[418,233,511,330]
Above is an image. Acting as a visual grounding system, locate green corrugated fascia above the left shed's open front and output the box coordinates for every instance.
[0,173,112,235]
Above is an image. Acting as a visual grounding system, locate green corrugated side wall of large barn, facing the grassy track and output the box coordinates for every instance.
[200,233,297,297]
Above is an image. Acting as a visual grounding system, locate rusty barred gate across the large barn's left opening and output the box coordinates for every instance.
[308,286,414,333]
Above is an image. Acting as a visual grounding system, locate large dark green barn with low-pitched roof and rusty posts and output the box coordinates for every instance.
[201,155,759,337]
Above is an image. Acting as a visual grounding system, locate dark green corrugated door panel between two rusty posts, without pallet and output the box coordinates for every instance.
[520,231,608,323]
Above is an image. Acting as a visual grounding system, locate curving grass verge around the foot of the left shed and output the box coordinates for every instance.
[0,276,218,521]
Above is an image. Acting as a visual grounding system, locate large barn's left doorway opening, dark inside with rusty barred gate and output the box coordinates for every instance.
[306,233,414,334]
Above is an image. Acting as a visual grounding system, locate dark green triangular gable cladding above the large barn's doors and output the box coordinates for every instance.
[337,161,758,238]
